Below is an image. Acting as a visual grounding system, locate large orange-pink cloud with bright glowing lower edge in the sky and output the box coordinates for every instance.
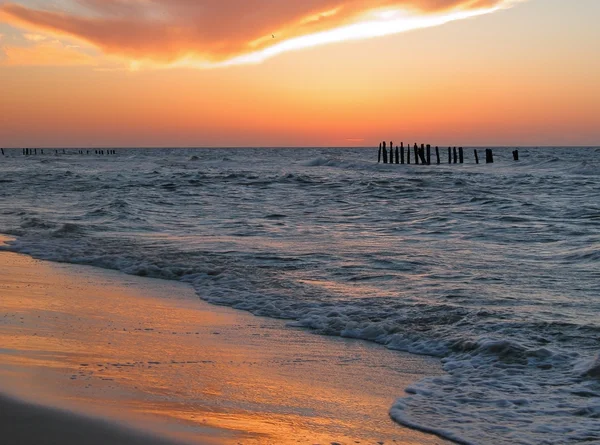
[0,0,515,66]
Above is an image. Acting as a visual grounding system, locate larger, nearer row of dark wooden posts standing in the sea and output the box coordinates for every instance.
[377,142,519,165]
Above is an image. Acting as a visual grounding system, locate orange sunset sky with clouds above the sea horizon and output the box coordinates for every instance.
[0,0,600,147]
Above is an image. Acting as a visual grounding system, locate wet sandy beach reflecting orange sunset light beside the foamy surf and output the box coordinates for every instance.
[0,248,448,445]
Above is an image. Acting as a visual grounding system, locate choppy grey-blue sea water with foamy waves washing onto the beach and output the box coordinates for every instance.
[0,148,600,444]
